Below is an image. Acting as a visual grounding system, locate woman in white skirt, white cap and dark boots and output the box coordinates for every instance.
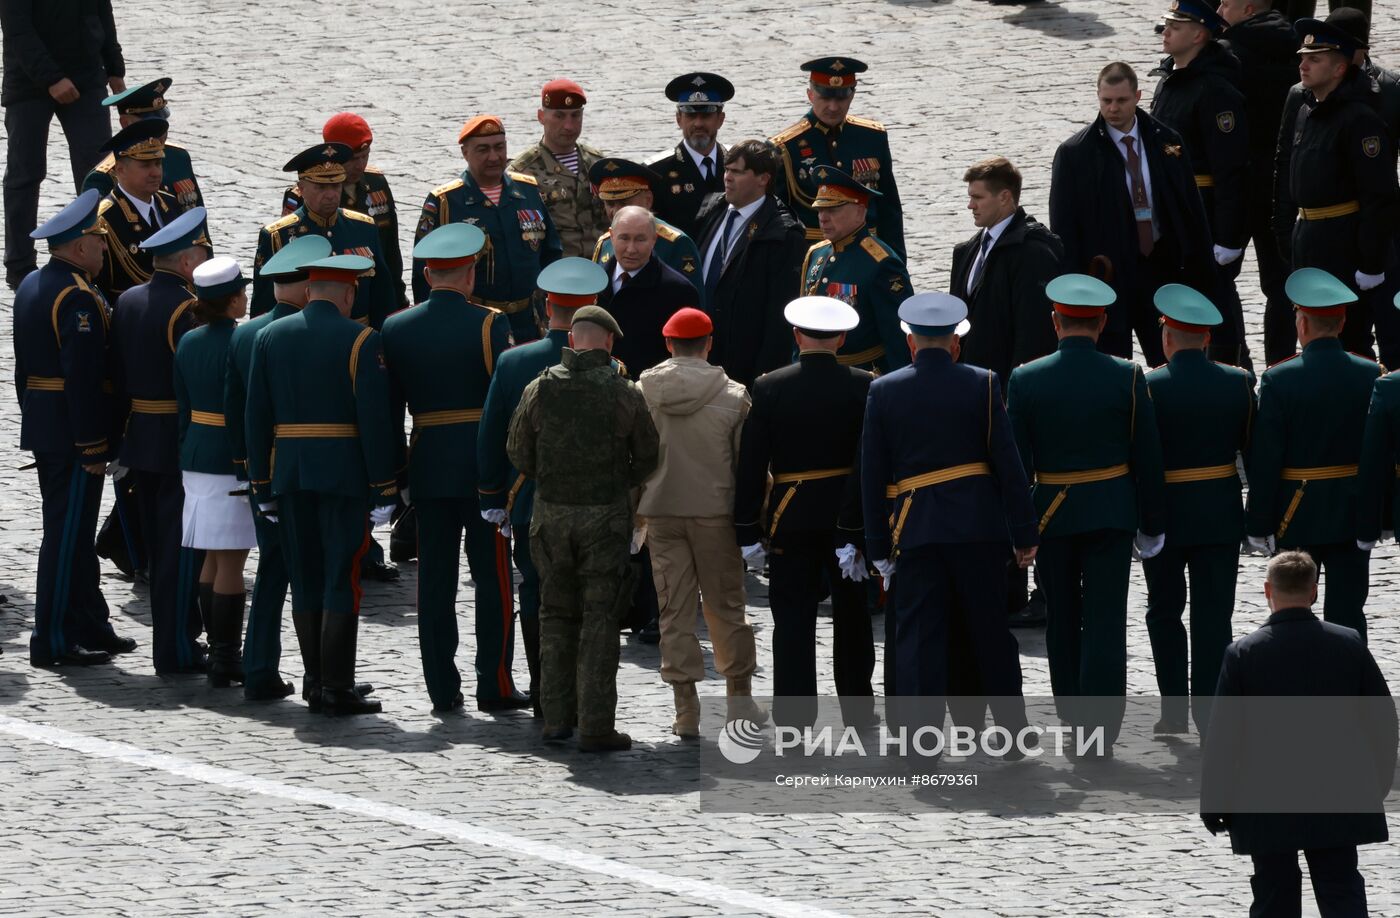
[175,256,258,687]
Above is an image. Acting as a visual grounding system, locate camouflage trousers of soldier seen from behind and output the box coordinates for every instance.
[529,495,634,736]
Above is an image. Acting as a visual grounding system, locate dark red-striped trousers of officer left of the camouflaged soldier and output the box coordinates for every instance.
[413,494,515,705]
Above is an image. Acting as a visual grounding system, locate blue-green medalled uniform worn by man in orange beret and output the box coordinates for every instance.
[413,171,560,341]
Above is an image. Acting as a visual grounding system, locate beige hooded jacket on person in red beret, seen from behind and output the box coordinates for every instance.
[637,357,750,516]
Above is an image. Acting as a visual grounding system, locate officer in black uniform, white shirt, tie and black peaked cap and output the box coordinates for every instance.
[644,73,734,238]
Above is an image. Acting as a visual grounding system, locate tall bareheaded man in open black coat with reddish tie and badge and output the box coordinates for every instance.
[1050,62,1215,367]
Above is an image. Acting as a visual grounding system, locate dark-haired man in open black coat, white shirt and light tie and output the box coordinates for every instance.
[699,140,806,386]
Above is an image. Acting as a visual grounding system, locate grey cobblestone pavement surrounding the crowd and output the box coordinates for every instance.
[0,0,1400,917]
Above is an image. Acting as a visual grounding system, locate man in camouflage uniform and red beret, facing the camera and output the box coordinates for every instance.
[511,80,608,257]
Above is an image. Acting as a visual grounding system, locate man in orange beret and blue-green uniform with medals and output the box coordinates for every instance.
[413,115,562,341]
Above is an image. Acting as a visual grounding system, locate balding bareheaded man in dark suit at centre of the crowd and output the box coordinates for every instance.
[598,207,700,379]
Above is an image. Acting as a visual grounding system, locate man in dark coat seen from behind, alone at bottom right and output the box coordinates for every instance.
[1201,551,1396,915]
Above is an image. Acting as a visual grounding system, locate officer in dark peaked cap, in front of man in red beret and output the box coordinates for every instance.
[252,143,399,329]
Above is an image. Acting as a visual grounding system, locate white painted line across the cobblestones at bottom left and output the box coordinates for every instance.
[0,715,844,918]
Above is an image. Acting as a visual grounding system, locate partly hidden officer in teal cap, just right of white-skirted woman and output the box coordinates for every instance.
[224,236,330,700]
